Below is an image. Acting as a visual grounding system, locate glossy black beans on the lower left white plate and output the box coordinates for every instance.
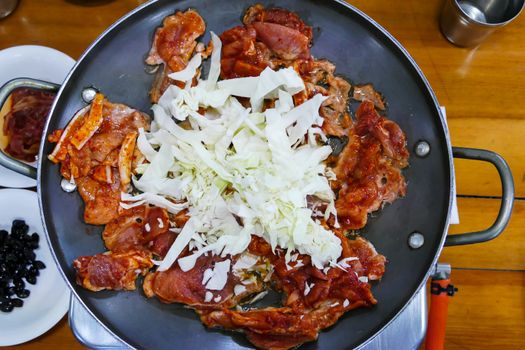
[0,220,46,312]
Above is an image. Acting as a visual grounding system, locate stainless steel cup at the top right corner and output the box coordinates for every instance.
[440,0,525,47]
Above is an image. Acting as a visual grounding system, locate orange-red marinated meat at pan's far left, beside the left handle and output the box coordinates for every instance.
[49,94,149,225]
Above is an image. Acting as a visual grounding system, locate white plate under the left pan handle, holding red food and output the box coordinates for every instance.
[0,45,75,188]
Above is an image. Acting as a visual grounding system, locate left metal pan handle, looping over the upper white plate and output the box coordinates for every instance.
[0,78,60,179]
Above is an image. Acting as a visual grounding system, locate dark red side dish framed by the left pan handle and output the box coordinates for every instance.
[3,88,55,162]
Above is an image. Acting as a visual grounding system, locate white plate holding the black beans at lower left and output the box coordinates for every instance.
[0,189,70,346]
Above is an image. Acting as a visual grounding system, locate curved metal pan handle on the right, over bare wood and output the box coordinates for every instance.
[445,147,514,246]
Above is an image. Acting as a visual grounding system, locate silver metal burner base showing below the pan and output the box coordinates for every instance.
[69,288,427,350]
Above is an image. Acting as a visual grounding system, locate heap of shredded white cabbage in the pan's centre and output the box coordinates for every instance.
[127,33,342,274]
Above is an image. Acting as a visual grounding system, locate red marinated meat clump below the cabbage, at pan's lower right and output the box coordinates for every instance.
[198,233,385,349]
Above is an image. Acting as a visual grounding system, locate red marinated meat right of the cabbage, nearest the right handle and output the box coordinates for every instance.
[334,101,409,229]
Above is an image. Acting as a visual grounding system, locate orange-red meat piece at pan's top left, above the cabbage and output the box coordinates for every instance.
[146,10,206,103]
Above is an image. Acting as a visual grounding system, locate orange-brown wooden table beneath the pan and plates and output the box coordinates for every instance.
[0,0,525,349]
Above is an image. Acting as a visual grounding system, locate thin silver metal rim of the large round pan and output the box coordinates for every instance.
[37,0,455,349]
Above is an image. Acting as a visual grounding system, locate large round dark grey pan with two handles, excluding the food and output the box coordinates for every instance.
[0,0,513,349]
